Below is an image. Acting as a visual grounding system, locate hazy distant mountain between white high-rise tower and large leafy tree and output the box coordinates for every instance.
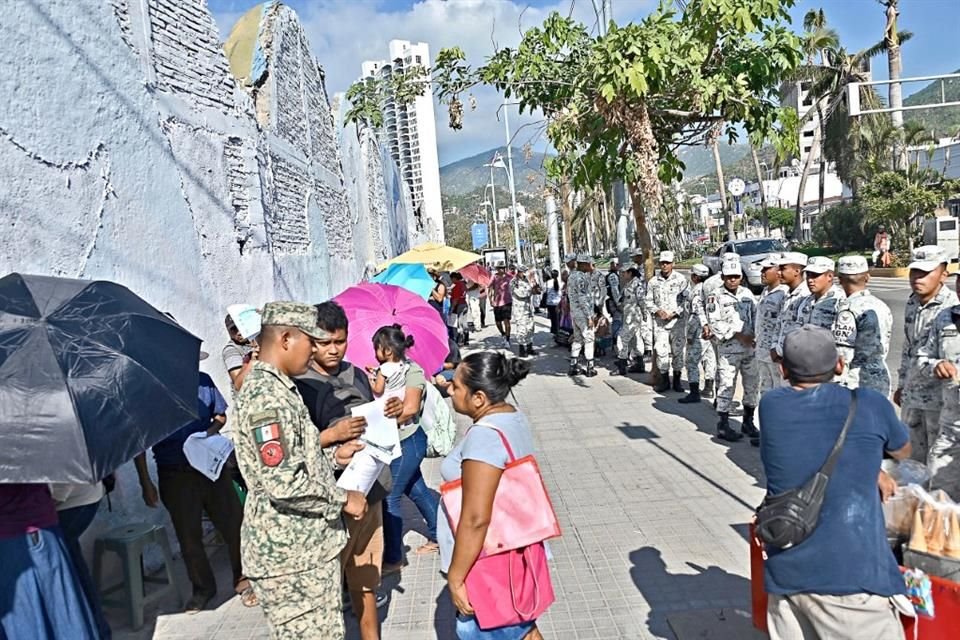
[440,147,551,195]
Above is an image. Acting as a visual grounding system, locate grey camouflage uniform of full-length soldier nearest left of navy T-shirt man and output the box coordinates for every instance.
[707,287,759,413]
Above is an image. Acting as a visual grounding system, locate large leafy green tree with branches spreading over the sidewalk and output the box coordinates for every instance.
[344,0,803,272]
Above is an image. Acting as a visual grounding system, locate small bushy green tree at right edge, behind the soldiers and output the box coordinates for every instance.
[860,168,960,252]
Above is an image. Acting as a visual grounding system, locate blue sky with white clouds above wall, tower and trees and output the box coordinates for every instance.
[208,0,960,165]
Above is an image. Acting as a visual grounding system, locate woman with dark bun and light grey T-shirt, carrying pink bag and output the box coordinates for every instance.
[439,351,542,640]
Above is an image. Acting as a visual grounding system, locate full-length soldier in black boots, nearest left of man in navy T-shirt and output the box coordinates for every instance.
[707,261,760,445]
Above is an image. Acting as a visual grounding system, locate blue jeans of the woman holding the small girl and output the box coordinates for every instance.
[383,428,440,564]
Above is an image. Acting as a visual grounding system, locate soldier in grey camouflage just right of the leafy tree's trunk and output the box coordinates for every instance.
[647,251,687,393]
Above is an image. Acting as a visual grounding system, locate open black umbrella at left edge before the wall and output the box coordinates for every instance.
[0,273,200,483]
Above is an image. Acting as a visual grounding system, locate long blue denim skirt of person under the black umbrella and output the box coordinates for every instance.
[0,526,99,640]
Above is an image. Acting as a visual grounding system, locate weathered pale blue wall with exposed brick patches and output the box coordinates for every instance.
[0,0,424,576]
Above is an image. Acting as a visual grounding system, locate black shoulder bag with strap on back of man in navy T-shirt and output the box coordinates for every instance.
[756,389,857,549]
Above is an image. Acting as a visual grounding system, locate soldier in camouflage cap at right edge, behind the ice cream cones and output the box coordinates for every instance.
[893,245,960,464]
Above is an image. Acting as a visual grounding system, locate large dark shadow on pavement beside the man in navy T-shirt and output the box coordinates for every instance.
[630,547,750,640]
